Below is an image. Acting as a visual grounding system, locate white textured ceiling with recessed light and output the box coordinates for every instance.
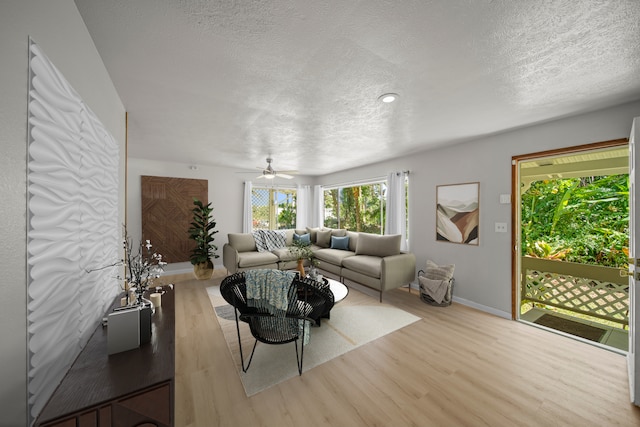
[76,0,640,175]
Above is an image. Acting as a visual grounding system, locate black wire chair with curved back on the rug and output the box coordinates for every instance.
[220,272,315,375]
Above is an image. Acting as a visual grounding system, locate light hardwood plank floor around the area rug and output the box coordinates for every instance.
[172,270,640,427]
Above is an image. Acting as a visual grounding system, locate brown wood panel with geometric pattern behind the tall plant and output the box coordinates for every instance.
[141,176,209,263]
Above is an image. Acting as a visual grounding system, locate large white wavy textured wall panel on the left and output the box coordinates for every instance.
[27,43,120,417]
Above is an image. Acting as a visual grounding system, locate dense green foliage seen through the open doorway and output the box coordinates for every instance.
[521,175,629,267]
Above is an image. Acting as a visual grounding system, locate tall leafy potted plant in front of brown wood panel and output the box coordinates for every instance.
[189,197,219,280]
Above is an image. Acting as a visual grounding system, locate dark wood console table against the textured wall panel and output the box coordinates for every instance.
[35,286,175,427]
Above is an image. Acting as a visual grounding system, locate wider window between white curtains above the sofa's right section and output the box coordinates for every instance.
[324,181,387,234]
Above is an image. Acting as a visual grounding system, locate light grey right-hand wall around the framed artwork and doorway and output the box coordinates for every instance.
[319,102,640,317]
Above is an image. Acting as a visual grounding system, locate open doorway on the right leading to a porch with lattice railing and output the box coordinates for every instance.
[513,140,629,352]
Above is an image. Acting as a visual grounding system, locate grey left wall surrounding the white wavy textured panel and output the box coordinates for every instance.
[0,0,125,426]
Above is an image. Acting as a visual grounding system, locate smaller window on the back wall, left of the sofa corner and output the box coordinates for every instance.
[251,187,297,230]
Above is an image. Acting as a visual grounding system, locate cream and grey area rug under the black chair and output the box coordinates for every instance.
[207,286,420,396]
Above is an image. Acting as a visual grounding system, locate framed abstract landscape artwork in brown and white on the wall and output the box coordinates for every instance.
[436,182,480,245]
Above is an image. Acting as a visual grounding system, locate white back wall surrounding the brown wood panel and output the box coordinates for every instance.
[127,158,316,273]
